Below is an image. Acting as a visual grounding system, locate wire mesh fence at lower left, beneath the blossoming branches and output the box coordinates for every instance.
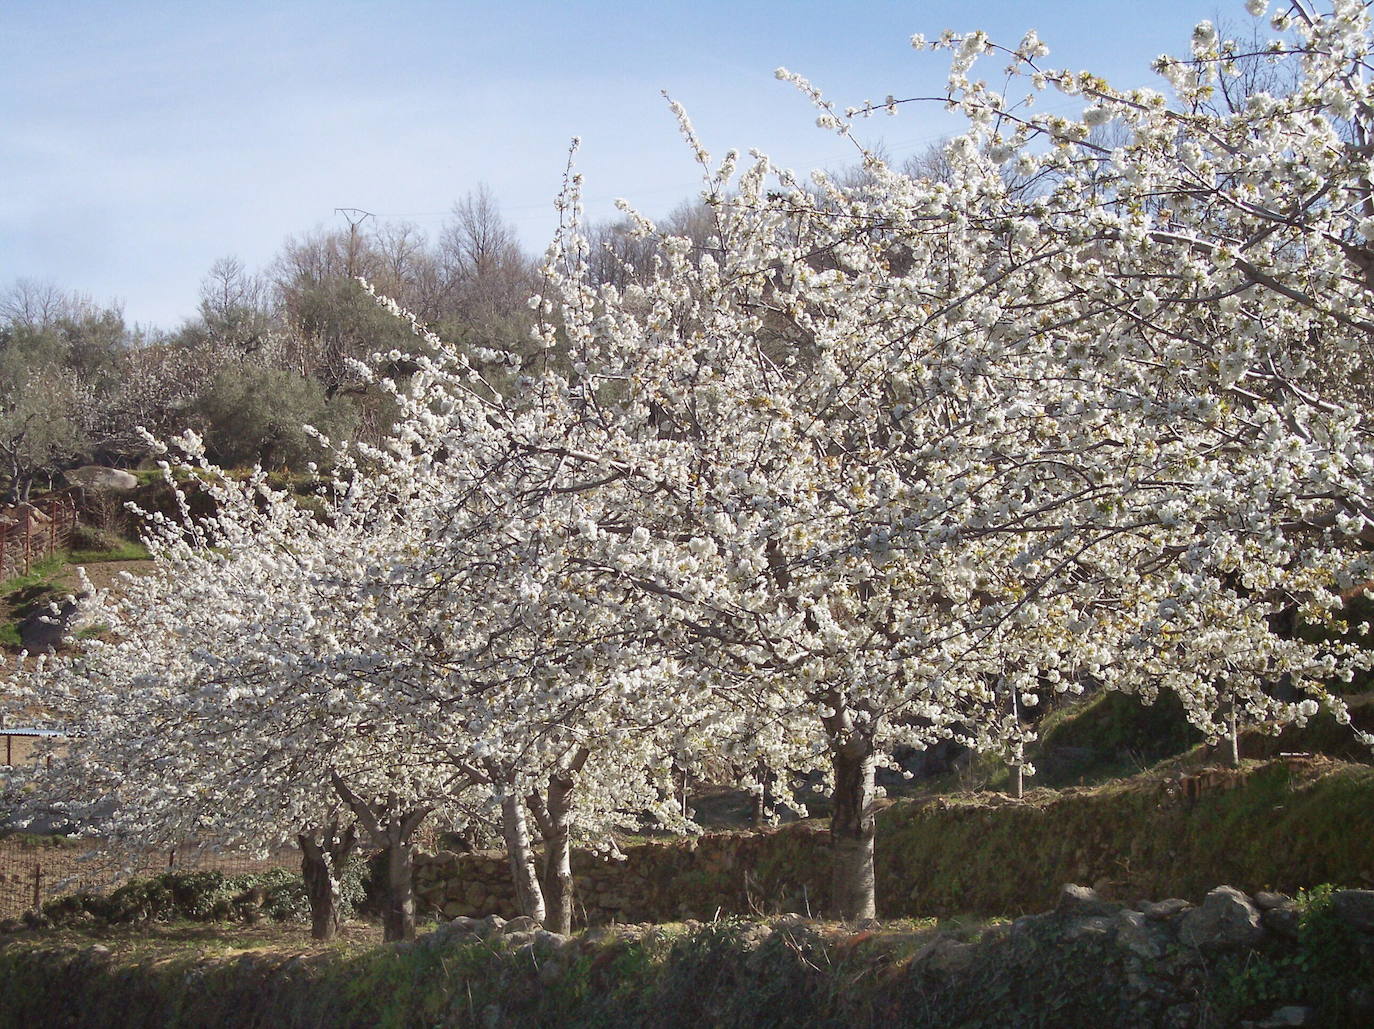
[0,837,301,919]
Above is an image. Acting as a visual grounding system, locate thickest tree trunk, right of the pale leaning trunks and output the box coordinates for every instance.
[830,732,877,922]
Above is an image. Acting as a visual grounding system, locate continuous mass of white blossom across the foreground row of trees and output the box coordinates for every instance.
[2,0,1374,915]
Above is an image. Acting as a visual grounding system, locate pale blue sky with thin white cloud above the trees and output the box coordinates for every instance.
[0,0,1248,327]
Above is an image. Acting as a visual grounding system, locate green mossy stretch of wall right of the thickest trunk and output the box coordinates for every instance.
[877,761,1374,915]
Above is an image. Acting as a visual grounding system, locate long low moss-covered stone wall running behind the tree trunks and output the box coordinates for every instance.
[418,760,1374,925]
